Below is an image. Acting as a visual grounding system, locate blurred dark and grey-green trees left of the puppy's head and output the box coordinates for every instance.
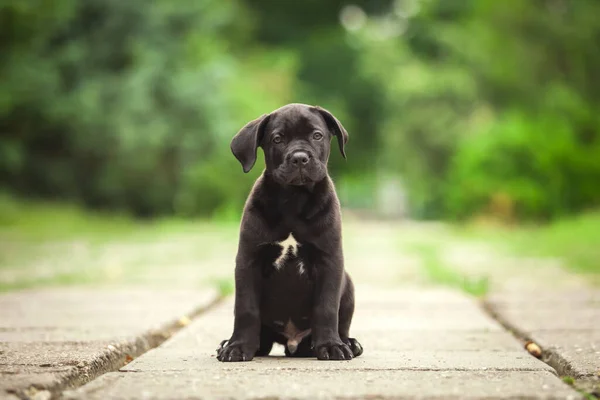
[0,0,296,215]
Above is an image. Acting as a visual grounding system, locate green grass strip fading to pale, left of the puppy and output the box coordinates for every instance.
[0,195,239,294]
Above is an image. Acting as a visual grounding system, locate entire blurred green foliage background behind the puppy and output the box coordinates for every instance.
[0,0,600,219]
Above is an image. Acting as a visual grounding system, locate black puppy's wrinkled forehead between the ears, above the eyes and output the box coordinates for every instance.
[269,107,327,135]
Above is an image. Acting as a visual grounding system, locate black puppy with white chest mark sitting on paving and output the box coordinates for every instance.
[217,104,363,361]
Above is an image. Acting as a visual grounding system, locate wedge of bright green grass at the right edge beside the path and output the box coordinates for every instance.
[465,211,600,280]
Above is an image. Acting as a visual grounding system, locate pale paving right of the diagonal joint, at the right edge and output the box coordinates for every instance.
[434,230,600,398]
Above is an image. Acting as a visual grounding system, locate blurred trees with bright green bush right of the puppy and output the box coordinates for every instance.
[358,0,600,218]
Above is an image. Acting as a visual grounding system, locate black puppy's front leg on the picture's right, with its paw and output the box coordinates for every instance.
[313,249,352,360]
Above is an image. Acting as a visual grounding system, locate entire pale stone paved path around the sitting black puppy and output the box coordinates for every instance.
[0,221,600,400]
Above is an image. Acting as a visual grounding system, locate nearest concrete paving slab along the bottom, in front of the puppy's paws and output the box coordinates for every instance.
[64,364,582,400]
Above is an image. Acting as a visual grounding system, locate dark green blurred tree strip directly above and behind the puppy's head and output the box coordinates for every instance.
[246,0,392,175]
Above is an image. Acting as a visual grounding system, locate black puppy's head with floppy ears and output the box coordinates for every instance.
[231,104,348,186]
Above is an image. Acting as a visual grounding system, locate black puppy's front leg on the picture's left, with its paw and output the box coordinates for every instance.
[217,252,261,361]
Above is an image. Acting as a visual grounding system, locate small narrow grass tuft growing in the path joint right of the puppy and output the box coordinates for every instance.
[406,242,488,297]
